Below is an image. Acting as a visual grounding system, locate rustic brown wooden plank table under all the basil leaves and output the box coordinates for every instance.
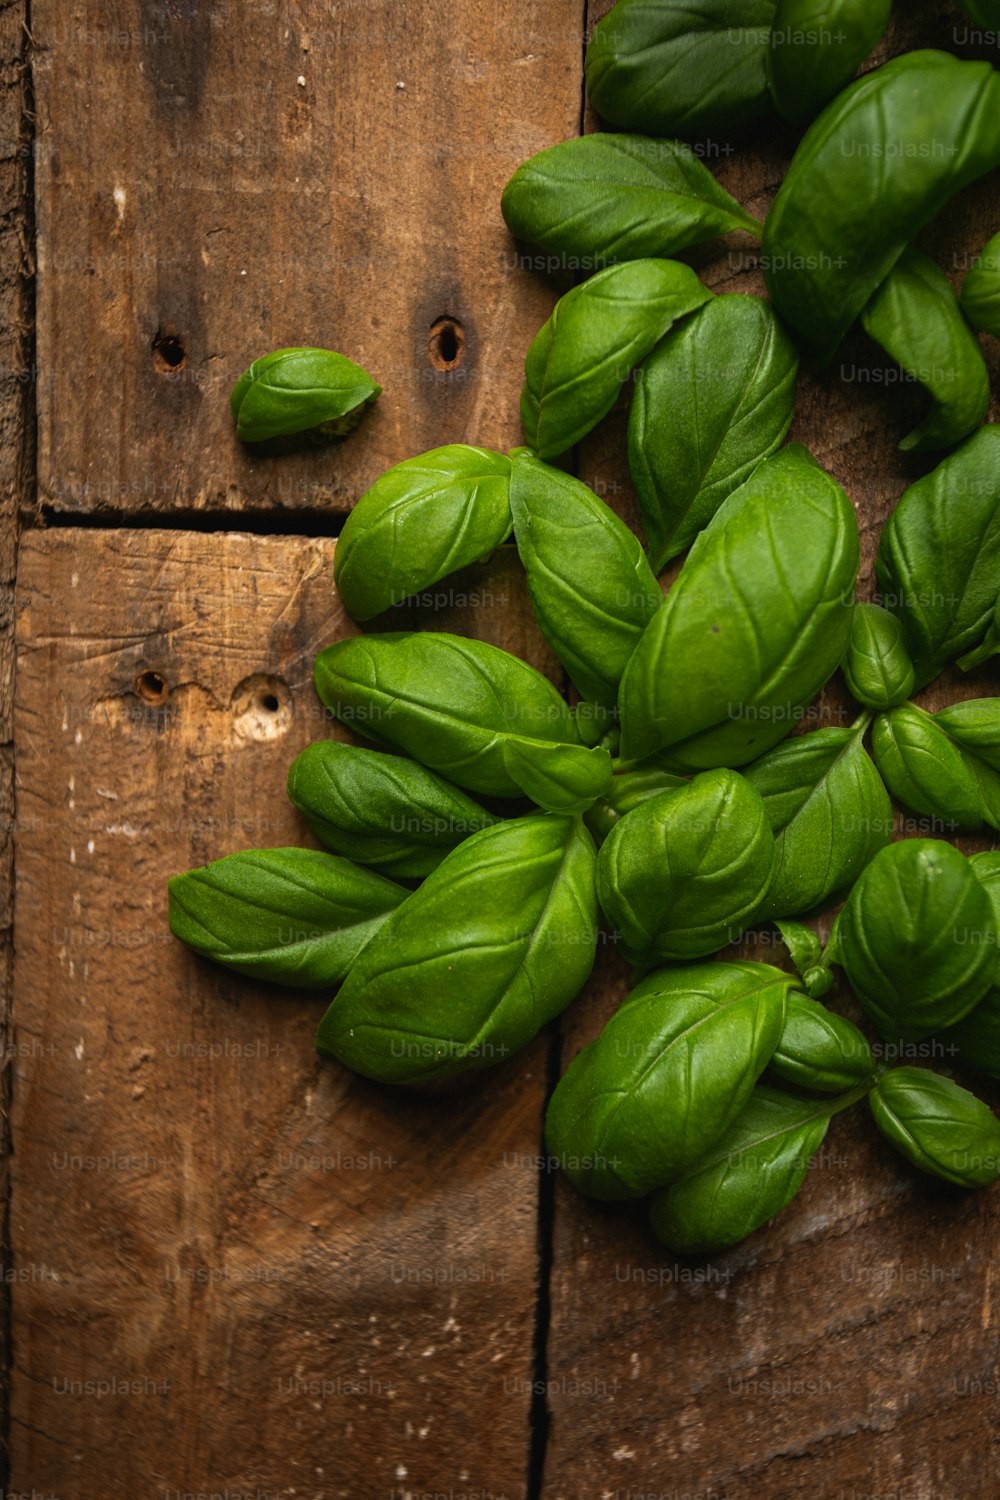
[0,0,1000,1500]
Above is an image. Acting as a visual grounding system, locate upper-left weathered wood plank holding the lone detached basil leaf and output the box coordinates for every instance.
[31,0,583,512]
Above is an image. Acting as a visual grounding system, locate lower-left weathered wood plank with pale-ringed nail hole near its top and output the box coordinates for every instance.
[12,530,546,1500]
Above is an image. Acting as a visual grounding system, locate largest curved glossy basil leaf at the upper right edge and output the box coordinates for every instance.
[763,51,1000,365]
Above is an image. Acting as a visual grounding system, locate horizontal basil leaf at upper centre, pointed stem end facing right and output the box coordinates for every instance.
[501,134,762,270]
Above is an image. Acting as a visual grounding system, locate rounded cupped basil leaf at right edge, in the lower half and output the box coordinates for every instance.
[835,839,997,1041]
